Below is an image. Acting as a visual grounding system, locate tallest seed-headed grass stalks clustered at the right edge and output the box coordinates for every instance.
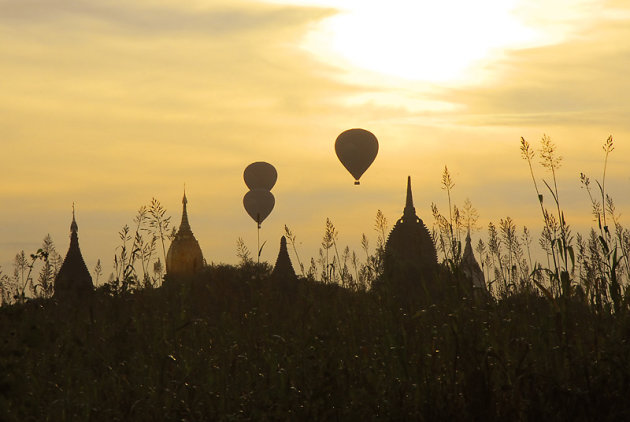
[521,135,630,317]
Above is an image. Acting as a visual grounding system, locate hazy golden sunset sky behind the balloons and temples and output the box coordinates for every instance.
[0,0,630,280]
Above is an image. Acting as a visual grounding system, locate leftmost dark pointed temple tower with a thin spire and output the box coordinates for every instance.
[55,204,94,297]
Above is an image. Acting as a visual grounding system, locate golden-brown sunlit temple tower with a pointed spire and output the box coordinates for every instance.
[166,191,204,277]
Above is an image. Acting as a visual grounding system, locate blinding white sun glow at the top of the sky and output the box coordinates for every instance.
[264,0,572,82]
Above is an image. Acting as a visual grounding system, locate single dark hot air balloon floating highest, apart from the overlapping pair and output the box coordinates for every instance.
[335,129,378,185]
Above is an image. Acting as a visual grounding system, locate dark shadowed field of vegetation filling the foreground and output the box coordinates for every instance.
[0,264,630,421]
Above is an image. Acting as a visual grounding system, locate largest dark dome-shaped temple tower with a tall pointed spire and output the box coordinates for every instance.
[384,176,437,281]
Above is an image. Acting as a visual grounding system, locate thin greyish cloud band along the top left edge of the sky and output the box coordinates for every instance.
[0,0,334,35]
